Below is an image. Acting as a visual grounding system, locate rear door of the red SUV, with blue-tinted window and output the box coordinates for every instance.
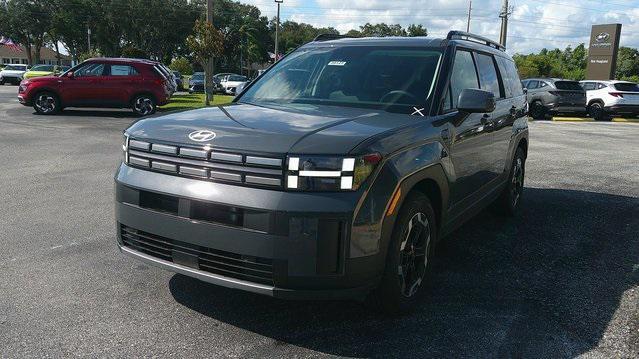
[103,63,142,107]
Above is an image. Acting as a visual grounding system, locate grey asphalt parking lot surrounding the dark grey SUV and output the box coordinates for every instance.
[0,86,639,358]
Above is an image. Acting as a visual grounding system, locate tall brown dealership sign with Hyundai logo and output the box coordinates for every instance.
[586,24,621,80]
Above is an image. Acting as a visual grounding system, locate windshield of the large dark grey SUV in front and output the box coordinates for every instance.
[239,46,441,112]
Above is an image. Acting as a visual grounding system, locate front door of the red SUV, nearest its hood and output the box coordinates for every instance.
[61,62,106,106]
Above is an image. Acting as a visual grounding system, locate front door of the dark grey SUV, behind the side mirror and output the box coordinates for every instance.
[444,49,500,210]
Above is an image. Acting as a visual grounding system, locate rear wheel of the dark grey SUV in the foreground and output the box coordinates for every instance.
[495,147,526,216]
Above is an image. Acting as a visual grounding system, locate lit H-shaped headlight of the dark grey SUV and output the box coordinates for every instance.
[286,153,382,192]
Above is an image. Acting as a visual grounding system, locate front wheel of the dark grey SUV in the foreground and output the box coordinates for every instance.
[374,192,437,314]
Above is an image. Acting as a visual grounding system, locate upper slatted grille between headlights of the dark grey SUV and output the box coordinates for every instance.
[127,139,284,188]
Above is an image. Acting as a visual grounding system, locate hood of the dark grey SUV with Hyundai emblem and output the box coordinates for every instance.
[126,104,415,154]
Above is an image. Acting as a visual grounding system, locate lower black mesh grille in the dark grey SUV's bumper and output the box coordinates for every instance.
[120,225,273,285]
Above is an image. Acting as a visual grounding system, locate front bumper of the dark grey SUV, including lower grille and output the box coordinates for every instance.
[116,165,384,299]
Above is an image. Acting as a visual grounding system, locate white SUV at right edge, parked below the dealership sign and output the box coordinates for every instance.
[581,80,639,120]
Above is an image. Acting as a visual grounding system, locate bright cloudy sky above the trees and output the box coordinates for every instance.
[240,0,639,54]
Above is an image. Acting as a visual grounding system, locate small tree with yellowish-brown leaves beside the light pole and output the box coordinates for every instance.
[186,20,224,106]
